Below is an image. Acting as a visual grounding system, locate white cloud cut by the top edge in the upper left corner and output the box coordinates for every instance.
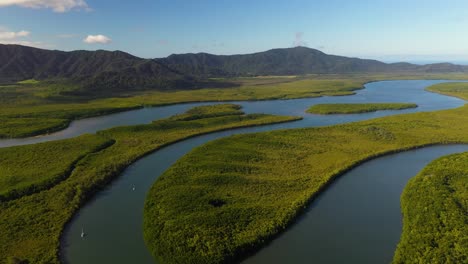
[0,0,90,13]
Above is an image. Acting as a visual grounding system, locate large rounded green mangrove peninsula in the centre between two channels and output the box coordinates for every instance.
[144,85,468,263]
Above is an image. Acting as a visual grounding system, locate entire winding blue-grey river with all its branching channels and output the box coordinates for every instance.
[0,80,468,263]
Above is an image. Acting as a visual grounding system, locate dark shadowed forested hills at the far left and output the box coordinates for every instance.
[0,45,194,94]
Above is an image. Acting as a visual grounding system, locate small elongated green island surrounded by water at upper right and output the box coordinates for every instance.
[307,103,418,115]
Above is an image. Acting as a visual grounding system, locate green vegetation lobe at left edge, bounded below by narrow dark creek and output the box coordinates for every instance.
[0,135,113,201]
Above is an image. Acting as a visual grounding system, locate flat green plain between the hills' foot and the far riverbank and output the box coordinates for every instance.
[0,74,468,138]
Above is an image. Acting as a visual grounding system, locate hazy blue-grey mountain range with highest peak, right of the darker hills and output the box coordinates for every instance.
[159,47,468,77]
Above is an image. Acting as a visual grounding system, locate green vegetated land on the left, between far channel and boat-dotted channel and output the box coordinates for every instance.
[0,104,301,263]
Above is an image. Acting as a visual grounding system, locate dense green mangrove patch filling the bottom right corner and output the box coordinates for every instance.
[393,152,468,263]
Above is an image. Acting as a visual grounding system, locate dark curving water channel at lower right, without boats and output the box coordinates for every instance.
[243,145,468,264]
